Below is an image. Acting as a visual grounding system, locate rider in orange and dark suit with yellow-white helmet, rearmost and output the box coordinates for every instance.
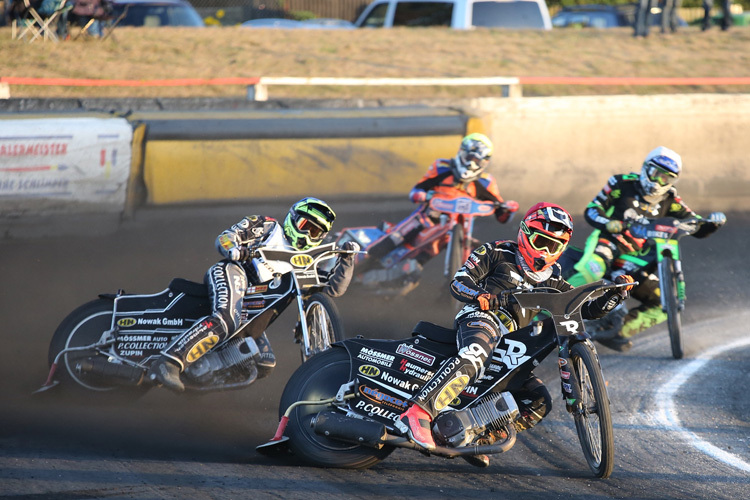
[367,133,518,258]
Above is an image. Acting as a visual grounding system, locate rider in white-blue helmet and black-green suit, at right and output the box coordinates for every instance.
[568,146,727,351]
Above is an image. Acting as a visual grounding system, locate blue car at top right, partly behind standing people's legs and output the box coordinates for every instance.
[552,4,687,28]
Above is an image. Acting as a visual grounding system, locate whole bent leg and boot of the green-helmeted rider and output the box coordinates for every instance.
[147,260,247,391]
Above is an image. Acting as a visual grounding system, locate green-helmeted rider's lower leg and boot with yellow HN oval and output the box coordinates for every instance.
[146,316,227,392]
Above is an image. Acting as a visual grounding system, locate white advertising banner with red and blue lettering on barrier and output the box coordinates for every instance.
[0,117,133,217]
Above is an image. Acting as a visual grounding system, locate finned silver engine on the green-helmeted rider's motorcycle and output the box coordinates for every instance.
[185,337,260,385]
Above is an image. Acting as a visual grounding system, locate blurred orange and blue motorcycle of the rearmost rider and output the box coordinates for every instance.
[336,189,513,296]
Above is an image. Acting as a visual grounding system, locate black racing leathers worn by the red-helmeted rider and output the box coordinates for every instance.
[412,241,621,430]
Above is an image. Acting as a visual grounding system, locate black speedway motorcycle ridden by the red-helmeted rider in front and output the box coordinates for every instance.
[257,281,627,478]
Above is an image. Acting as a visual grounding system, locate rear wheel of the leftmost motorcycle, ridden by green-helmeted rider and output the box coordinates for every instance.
[47,299,148,396]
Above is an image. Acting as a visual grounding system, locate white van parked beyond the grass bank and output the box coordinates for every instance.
[354,0,552,30]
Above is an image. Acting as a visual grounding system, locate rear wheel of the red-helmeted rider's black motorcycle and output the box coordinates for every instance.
[279,347,393,469]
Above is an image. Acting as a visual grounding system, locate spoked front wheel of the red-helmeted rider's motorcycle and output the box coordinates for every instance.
[570,343,615,478]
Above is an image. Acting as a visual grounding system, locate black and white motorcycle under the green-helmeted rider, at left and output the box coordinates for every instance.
[40,243,353,393]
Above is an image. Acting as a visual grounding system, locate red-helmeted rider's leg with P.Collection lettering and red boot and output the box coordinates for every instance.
[396,312,501,450]
